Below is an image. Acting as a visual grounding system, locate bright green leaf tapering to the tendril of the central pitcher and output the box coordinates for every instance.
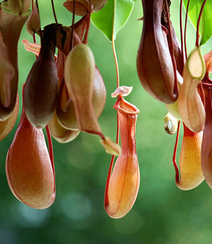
[91,0,134,41]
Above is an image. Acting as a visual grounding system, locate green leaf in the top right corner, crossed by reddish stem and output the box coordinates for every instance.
[183,0,212,45]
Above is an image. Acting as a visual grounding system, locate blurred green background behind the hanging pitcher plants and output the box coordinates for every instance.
[0,0,212,244]
